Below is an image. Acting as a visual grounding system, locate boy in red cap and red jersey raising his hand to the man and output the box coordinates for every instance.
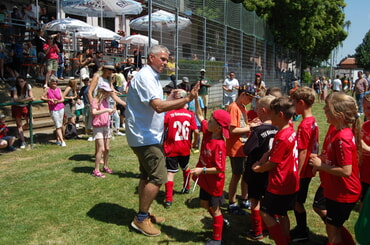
[190,93,231,244]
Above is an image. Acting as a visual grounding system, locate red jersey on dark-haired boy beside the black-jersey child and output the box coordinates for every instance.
[267,127,299,195]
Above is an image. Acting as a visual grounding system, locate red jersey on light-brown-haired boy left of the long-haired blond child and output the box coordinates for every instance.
[297,117,319,178]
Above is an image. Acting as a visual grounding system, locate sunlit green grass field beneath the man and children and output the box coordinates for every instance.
[0,104,358,245]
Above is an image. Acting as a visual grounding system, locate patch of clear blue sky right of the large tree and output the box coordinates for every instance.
[337,0,370,63]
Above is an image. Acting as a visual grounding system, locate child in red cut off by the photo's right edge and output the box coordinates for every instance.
[358,92,370,210]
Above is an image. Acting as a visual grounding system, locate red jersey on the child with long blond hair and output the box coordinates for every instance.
[324,128,361,203]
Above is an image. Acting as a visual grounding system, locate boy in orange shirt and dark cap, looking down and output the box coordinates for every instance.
[226,85,254,215]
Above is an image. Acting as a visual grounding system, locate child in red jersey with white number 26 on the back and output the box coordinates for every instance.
[163,90,199,208]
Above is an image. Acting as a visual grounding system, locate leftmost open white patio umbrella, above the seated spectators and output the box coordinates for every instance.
[42,18,94,32]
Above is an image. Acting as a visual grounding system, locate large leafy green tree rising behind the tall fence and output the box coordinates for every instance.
[236,0,347,66]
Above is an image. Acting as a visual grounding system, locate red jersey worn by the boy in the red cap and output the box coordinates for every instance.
[197,120,226,196]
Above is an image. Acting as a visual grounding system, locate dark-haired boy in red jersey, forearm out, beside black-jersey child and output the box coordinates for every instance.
[252,96,299,245]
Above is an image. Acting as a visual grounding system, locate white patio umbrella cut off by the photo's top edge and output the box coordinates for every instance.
[62,0,143,18]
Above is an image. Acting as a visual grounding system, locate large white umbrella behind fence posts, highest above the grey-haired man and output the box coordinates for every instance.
[130,10,191,32]
